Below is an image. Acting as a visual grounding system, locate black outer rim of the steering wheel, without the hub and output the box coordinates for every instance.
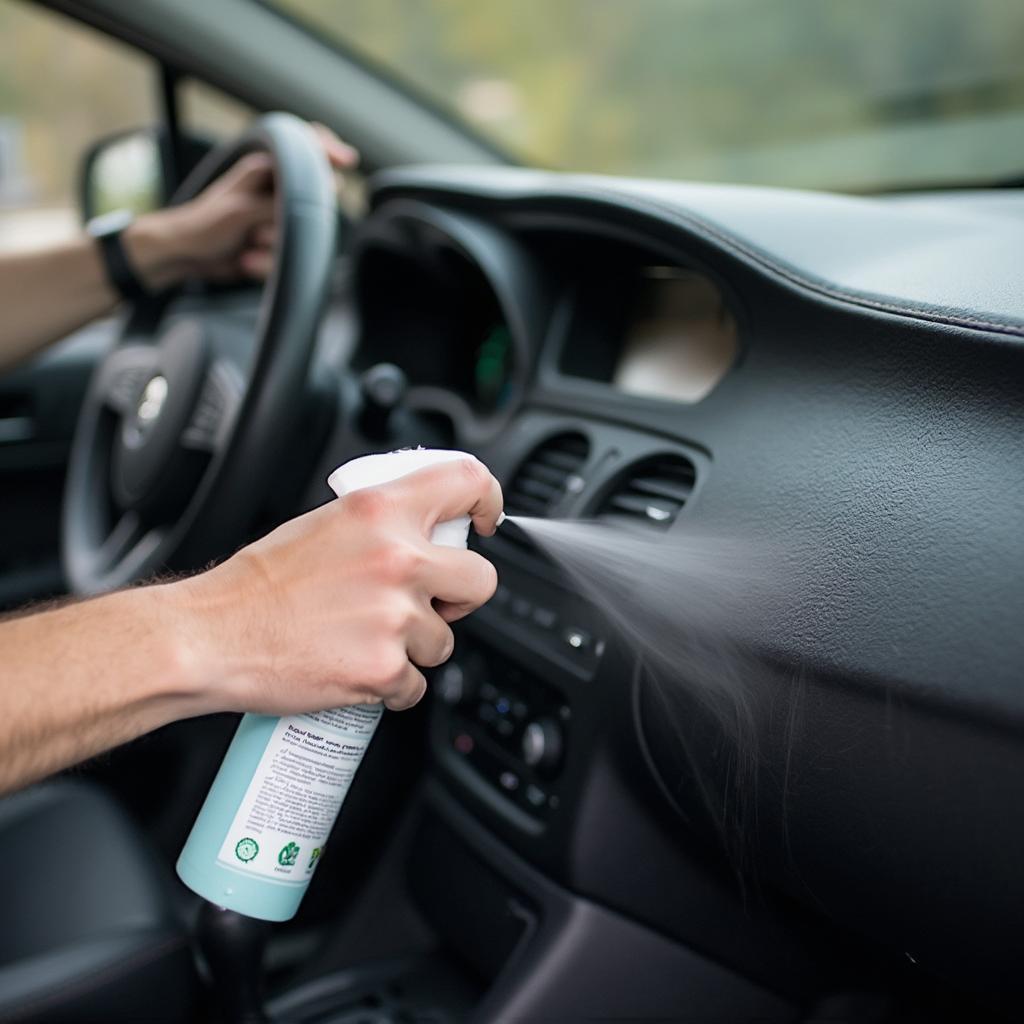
[61,113,338,594]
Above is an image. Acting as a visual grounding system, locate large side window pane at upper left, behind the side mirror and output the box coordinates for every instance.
[0,0,157,251]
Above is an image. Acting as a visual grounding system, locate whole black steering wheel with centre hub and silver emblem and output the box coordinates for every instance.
[61,114,337,594]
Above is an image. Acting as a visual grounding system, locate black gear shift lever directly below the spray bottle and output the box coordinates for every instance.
[197,900,270,1024]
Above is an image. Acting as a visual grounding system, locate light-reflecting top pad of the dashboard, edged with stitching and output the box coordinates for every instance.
[377,167,1024,337]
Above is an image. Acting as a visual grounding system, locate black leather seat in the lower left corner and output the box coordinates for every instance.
[0,781,197,1022]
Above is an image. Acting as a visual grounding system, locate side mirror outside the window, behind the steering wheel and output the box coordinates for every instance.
[80,128,167,220]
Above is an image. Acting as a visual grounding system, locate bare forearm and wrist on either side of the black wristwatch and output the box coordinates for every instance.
[0,213,188,370]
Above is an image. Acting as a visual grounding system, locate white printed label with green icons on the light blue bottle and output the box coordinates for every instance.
[211,705,384,887]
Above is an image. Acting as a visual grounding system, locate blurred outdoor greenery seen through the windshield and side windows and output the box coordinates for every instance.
[0,0,1024,248]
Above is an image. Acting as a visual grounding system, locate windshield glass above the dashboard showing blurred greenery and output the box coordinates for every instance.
[280,0,1024,190]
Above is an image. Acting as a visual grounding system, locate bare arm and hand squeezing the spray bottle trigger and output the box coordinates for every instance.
[0,461,502,793]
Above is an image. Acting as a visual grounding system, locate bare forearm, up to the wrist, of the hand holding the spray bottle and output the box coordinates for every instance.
[0,585,214,793]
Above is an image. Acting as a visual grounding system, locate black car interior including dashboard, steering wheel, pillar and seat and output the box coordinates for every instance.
[0,0,1024,1024]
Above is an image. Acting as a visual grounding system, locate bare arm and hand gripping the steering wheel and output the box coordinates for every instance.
[0,127,358,370]
